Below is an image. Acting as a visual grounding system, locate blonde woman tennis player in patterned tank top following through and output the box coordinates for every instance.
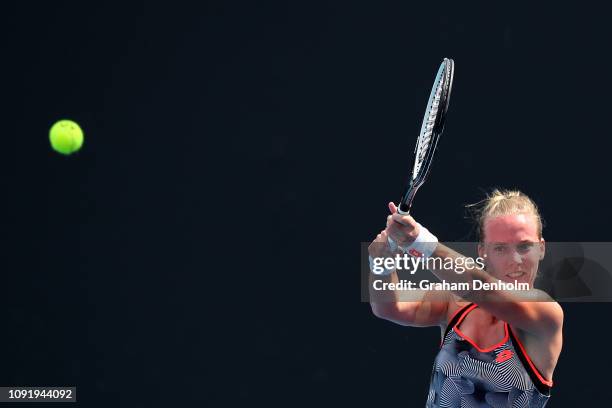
[369,190,563,407]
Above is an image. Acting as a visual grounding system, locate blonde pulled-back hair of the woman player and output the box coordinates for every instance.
[466,188,543,242]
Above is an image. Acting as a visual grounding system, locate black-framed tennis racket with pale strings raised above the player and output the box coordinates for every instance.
[397,58,455,214]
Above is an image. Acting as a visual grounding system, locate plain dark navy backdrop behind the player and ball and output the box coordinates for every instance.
[0,1,612,407]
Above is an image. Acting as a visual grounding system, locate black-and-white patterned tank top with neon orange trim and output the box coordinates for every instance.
[426,303,552,408]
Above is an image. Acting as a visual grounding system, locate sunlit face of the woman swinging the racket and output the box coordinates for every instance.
[478,214,545,285]
